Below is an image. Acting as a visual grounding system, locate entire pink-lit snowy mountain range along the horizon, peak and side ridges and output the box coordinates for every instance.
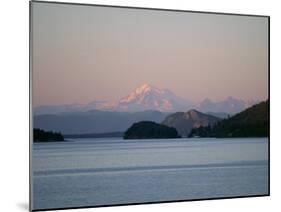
[34,83,258,116]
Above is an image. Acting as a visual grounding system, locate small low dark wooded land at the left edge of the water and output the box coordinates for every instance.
[33,128,65,142]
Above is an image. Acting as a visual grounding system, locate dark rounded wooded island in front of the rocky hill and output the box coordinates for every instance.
[123,121,180,139]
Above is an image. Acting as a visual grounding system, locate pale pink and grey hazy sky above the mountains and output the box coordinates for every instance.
[32,2,268,106]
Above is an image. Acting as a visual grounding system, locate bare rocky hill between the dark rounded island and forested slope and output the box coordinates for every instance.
[162,109,220,137]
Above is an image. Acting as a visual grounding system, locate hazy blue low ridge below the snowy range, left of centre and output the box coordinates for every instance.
[33,110,168,135]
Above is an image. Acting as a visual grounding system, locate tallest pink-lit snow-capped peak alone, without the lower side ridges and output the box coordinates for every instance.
[116,84,192,112]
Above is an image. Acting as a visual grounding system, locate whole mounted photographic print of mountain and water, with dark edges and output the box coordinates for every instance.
[30,1,269,211]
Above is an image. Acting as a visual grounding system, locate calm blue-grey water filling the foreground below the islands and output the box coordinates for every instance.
[33,138,268,209]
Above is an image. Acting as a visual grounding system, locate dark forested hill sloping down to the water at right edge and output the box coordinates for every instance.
[189,100,269,137]
